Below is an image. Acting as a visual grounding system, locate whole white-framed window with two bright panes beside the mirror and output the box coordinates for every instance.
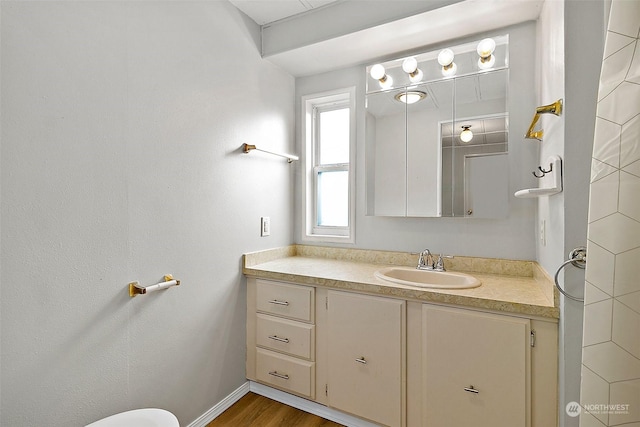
[303,89,355,242]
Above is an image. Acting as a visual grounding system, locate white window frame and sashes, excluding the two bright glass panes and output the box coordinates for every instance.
[301,87,356,243]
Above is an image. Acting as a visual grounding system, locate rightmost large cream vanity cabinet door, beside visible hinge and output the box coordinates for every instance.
[422,305,530,427]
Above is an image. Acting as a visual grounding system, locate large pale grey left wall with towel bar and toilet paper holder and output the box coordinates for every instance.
[0,1,294,426]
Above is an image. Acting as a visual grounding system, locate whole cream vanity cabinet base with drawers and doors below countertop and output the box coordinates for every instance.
[246,277,558,427]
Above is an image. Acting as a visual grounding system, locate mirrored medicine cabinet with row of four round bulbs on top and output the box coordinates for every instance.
[365,35,509,218]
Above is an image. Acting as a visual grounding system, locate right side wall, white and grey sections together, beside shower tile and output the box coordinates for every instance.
[537,1,606,427]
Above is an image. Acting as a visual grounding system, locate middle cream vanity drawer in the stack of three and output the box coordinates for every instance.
[256,314,315,359]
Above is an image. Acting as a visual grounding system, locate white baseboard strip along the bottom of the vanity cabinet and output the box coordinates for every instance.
[249,381,379,427]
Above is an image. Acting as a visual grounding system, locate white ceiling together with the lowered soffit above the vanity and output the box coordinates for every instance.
[229,0,544,77]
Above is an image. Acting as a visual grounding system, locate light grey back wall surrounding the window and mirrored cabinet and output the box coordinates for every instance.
[295,22,538,260]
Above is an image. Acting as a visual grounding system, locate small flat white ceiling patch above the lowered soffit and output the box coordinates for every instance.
[230,0,338,25]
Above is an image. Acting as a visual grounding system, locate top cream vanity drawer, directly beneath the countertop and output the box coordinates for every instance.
[256,280,315,322]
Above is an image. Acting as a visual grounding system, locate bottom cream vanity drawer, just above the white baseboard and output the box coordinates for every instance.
[256,348,315,399]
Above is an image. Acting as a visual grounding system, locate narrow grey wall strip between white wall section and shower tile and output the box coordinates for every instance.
[560,4,606,427]
